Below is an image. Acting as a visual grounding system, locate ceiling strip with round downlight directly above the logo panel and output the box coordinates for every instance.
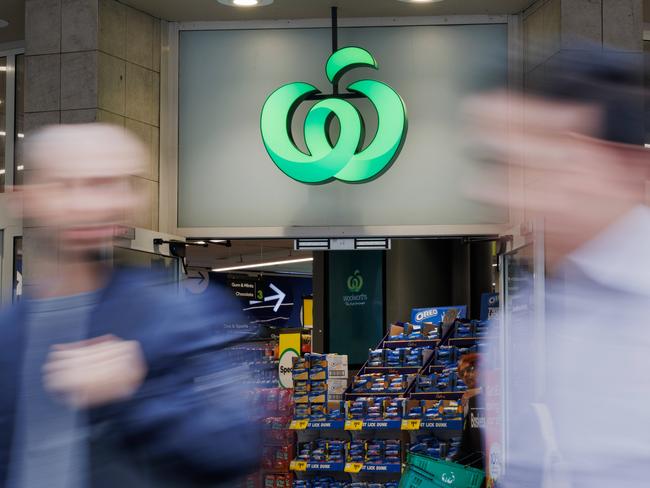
[123,0,534,21]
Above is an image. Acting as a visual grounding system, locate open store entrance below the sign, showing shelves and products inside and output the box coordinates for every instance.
[180,236,499,488]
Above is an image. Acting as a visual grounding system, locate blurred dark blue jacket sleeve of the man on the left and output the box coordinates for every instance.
[88,287,261,481]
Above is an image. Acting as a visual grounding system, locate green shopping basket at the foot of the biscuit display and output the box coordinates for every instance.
[399,454,485,488]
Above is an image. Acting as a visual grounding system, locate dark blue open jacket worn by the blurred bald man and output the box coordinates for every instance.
[0,271,261,488]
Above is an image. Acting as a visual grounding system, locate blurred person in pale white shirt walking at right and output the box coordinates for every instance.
[466,47,650,488]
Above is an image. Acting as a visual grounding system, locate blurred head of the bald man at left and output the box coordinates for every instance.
[22,124,148,259]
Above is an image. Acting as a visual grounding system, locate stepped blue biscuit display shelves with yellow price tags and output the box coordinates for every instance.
[290,321,492,488]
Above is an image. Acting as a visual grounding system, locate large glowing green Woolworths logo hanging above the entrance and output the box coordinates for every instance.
[261,47,407,184]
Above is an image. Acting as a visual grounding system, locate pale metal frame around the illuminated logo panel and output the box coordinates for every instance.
[159,15,523,239]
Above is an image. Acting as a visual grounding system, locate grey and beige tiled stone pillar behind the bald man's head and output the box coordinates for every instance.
[25,0,161,230]
